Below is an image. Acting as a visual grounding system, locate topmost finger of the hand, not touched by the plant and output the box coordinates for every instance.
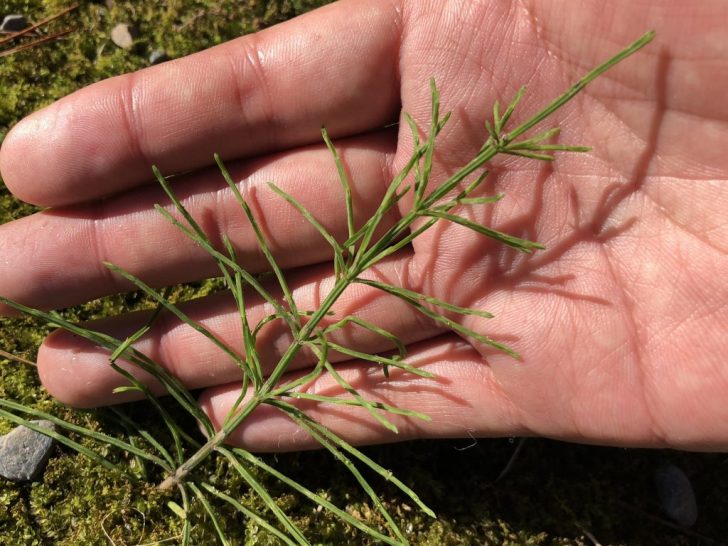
[0,0,399,206]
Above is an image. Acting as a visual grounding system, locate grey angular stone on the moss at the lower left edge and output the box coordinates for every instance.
[0,420,55,482]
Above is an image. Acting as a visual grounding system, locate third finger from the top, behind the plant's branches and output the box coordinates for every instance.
[38,251,442,407]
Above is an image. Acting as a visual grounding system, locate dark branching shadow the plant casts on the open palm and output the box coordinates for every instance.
[404,53,669,340]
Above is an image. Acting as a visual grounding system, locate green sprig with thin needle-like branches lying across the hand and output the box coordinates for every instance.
[0,33,653,544]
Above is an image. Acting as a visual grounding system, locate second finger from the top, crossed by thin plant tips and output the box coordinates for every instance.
[0,131,396,314]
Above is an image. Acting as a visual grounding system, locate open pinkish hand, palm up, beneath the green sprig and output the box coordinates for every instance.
[0,0,728,450]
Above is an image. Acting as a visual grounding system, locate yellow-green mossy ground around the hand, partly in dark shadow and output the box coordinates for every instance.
[0,0,728,546]
